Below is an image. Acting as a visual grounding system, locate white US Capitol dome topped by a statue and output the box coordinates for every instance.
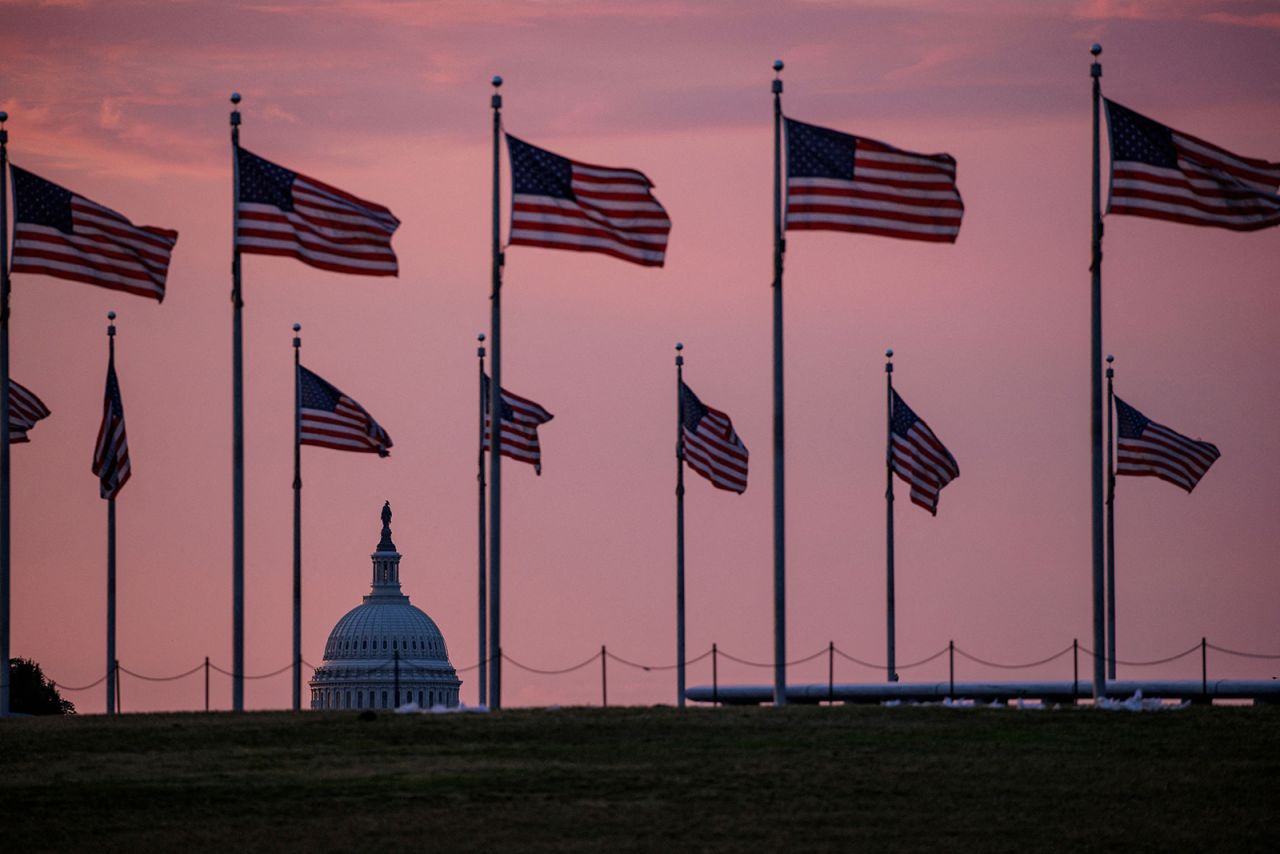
[310,502,462,709]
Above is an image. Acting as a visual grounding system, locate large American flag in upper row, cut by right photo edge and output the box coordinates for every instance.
[1107,100,1280,232]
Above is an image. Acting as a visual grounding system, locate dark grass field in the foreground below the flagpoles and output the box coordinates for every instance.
[0,707,1280,853]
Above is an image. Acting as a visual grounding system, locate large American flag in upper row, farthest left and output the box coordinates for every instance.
[12,166,178,300]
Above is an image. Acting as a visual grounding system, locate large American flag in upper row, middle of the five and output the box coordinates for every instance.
[507,133,671,266]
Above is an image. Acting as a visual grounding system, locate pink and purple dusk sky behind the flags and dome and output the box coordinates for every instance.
[0,0,1280,712]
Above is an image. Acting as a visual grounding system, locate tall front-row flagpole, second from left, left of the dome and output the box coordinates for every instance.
[232,92,244,712]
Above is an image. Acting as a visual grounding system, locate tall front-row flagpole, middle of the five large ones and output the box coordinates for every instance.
[489,74,503,709]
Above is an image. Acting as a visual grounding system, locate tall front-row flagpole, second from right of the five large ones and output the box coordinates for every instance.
[773,59,787,705]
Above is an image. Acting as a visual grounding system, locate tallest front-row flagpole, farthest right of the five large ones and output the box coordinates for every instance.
[1089,44,1107,700]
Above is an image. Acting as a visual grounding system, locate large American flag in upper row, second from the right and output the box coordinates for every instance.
[786,119,964,243]
